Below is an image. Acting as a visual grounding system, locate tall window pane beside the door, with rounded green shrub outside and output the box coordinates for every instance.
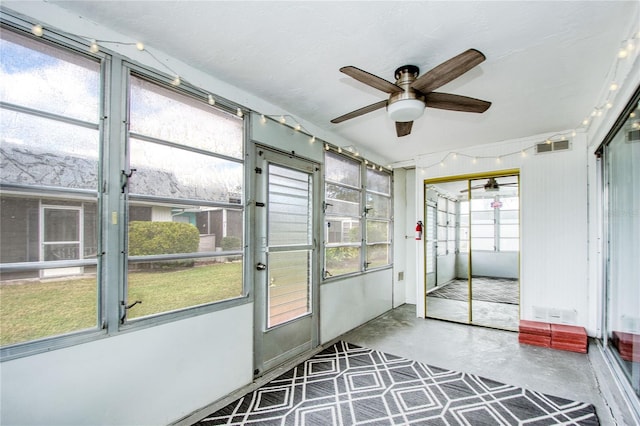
[127,75,244,319]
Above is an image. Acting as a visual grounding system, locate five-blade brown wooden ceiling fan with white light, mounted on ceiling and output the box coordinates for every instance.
[331,49,491,137]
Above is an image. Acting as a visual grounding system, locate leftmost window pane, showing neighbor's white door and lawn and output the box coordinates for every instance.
[0,29,101,346]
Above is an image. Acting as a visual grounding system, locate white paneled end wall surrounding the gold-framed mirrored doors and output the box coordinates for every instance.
[408,134,597,334]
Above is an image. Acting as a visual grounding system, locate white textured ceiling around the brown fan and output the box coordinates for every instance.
[18,0,639,162]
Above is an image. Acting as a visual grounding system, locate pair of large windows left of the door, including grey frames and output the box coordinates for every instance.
[0,23,246,358]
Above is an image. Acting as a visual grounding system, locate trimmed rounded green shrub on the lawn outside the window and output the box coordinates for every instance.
[129,221,200,269]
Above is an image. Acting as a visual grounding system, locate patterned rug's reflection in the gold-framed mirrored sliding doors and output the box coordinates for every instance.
[428,277,519,305]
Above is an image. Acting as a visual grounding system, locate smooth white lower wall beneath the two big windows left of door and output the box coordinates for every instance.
[0,304,253,426]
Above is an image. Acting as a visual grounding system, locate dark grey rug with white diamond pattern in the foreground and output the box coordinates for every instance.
[196,342,600,426]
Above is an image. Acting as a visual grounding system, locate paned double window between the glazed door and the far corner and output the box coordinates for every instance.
[324,151,392,278]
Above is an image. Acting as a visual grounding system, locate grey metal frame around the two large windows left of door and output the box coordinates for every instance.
[0,17,253,361]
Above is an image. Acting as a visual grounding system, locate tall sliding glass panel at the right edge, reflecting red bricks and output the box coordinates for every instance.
[599,85,640,415]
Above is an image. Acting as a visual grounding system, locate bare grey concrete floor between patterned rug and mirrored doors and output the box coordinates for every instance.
[340,305,638,425]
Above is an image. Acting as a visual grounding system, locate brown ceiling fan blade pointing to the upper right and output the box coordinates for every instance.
[411,49,486,94]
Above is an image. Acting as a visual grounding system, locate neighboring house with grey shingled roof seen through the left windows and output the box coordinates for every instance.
[0,141,243,280]
